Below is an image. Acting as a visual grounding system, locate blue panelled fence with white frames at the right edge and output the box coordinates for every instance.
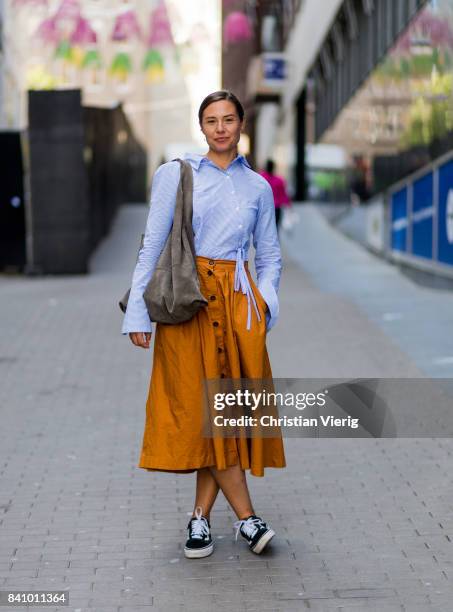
[388,152,453,272]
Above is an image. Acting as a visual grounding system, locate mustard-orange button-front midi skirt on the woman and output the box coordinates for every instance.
[138,256,286,476]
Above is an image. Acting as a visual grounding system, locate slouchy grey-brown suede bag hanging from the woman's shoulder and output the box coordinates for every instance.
[119,158,208,331]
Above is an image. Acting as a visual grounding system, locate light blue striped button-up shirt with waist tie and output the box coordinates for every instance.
[121,154,282,334]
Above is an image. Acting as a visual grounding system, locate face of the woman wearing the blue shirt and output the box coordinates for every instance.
[201,100,244,153]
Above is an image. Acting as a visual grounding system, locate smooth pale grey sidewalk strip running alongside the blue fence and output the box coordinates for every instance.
[282,205,453,378]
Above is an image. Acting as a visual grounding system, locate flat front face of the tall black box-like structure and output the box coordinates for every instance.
[29,90,89,273]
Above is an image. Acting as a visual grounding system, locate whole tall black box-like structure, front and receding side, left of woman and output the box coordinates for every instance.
[27,90,147,274]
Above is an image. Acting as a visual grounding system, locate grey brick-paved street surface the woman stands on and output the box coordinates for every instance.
[0,206,453,612]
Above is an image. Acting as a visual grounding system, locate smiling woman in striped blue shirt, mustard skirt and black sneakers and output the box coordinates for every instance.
[122,91,286,558]
